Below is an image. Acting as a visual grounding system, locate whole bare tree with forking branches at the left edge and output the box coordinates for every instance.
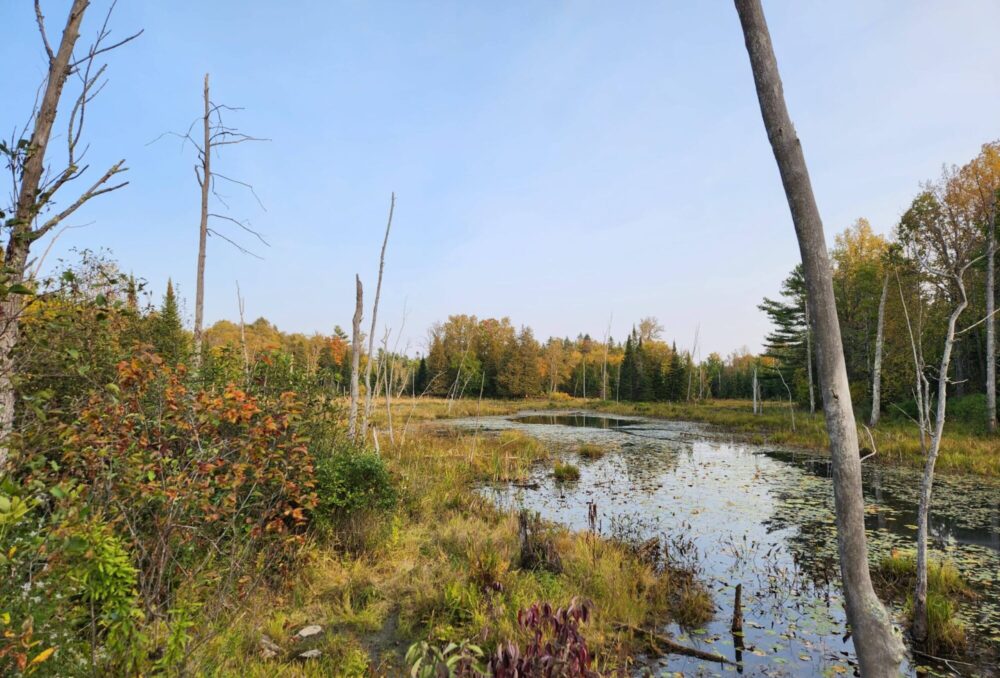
[0,0,142,473]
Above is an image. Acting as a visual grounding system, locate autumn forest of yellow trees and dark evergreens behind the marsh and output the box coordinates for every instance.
[178,142,1000,430]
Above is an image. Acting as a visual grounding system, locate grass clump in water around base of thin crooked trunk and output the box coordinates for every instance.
[875,551,975,652]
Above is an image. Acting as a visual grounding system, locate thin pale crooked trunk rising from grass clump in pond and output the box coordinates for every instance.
[913,276,968,643]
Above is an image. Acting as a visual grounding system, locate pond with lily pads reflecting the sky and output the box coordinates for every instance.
[455,412,1000,676]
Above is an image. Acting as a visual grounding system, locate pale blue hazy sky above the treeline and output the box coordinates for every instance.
[0,0,1000,353]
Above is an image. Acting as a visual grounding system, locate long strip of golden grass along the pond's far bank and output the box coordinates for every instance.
[368,396,1000,477]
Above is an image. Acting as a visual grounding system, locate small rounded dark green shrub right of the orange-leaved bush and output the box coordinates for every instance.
[316,450,397,520]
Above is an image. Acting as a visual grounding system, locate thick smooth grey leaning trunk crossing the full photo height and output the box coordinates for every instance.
[735,0,903,678]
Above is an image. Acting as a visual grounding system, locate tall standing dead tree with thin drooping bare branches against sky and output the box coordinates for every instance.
[158,73,269,368]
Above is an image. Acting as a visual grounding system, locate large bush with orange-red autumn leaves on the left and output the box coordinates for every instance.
[24,352,317,632]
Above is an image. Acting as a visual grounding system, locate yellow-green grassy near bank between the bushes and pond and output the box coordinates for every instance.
[192,424,712,676]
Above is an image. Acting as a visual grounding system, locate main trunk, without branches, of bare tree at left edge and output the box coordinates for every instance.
[0,0,90,474]
